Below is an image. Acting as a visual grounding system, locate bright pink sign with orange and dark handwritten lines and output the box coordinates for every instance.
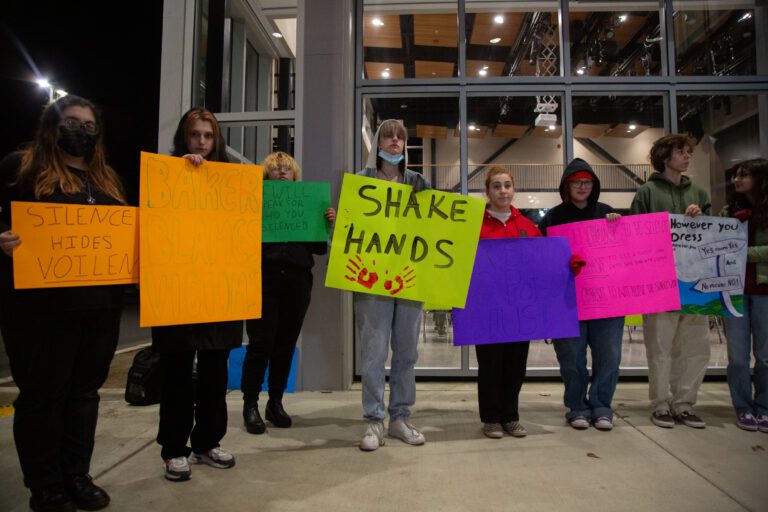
[547,213,680,320]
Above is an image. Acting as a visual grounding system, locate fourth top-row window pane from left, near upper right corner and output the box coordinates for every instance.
[672,0,766,76]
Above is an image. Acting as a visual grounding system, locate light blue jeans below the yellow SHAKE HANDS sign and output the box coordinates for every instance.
[355,293,422,422]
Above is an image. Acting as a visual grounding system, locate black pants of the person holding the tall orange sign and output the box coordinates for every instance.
[157,349,229,459]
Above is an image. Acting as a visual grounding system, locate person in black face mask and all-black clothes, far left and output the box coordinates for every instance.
[0,94,125,511]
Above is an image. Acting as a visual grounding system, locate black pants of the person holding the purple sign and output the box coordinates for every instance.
[475,341,530,423]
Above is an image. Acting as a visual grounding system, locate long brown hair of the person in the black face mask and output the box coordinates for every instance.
[15,94,125,204]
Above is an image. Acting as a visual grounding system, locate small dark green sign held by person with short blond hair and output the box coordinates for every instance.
[262,180,331,242]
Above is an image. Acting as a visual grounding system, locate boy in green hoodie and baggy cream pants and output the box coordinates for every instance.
[630,134,711,428]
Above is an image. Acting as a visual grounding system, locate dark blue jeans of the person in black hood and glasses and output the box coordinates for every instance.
[552,316,624,421]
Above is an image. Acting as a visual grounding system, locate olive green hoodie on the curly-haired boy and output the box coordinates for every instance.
[630,172,712,215]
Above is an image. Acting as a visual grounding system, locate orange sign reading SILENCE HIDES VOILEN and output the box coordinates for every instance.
[11,201,139,289]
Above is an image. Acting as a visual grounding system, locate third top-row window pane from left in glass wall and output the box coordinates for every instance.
[569,1,664,76]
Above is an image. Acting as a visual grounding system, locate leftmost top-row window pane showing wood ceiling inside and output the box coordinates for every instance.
[363,0,459,80]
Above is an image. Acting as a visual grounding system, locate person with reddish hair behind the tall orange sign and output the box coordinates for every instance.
[152,108,243,482]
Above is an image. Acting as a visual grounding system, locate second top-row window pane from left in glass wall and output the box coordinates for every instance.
[466,0,560,78]
